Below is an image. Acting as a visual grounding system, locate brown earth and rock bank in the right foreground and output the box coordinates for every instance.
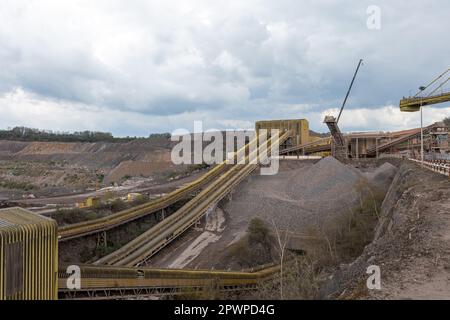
[323,162,450,299]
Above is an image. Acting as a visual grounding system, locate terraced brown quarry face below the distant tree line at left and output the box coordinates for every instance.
[0,138,175,198]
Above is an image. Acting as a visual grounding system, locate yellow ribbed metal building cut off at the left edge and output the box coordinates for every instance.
[0,208,58,300]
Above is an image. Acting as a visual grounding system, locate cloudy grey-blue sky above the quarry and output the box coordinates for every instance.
[0,0,450,136]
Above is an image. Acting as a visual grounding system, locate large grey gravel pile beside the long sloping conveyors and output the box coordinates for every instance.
[225,157,362,239]
